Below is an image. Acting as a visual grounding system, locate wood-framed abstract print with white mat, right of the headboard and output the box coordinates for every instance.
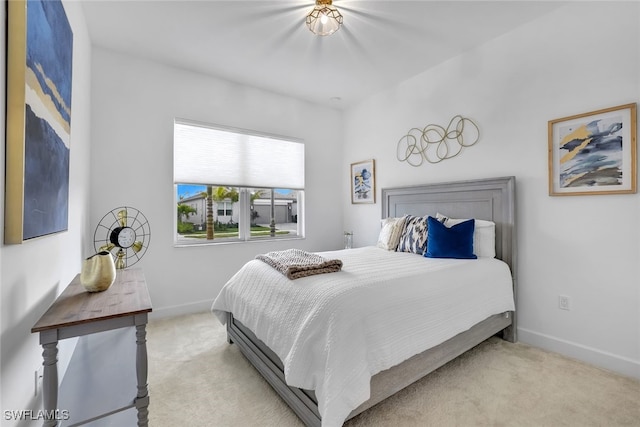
[549,104,637,196]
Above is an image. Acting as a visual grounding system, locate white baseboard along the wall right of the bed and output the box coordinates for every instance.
[518,328,640,379]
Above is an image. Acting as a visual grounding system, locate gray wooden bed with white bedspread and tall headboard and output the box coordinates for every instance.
[212,177,516,426]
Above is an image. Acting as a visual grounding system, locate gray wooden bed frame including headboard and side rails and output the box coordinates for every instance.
[227,177,516,426]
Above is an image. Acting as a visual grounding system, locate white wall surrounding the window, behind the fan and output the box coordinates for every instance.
[91,47,343,315]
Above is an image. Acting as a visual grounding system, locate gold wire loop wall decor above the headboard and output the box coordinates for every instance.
[396,115,480,167]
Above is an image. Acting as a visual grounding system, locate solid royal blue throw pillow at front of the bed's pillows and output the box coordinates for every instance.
[424,216,478,259]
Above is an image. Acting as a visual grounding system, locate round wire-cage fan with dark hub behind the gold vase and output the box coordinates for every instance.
[93,206,151,269]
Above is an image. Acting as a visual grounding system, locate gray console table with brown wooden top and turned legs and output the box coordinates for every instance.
[31,268,152,427]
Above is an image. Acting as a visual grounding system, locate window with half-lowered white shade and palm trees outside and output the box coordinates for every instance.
[174,120,304,245]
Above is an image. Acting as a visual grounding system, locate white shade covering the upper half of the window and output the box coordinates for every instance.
[173,120,304,190]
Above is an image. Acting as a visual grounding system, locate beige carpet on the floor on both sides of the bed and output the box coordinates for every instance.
[147,312,640,427]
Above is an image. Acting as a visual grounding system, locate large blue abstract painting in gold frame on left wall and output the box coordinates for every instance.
[4,0,73,243]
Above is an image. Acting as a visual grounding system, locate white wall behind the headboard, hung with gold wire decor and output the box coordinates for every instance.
[342,2,640,377]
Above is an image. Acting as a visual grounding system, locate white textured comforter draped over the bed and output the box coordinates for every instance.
[212,247,515,427]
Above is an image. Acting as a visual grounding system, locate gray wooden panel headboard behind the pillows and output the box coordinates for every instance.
[382,176,516,278]
